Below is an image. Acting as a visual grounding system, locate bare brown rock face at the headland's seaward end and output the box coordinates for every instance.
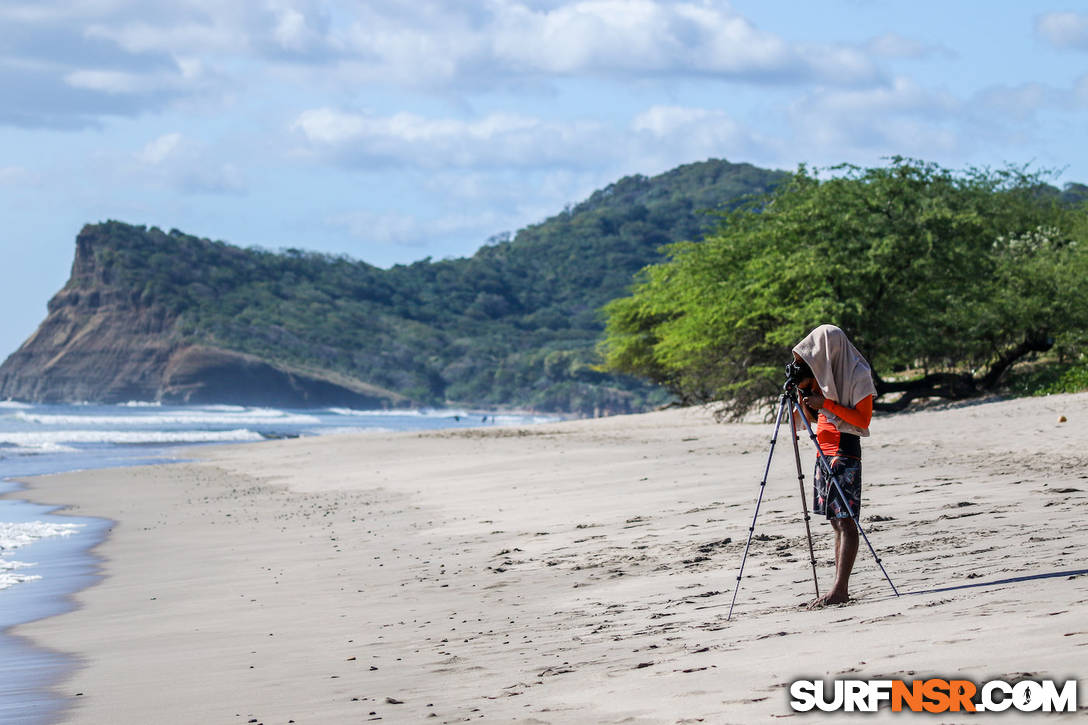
[0,225,408,408]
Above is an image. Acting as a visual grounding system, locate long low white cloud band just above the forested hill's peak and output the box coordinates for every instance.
[292,106,786,179]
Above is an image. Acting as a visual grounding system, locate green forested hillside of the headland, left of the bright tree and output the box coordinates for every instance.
[0,160,786,415]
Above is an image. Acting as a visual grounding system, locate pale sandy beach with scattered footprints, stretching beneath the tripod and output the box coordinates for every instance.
[10,394,1088,725]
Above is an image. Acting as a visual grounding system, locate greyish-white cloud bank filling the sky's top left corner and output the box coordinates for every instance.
[0,0,335,128]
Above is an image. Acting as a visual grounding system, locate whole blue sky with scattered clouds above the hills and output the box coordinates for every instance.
[0,0,1088,356]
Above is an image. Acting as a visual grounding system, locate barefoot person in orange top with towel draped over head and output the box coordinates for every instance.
[793,324,877,607]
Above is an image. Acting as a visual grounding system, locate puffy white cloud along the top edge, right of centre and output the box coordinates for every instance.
[345,0,880,86]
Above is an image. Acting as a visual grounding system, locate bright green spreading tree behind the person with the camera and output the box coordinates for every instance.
[603,158,1088,415]
